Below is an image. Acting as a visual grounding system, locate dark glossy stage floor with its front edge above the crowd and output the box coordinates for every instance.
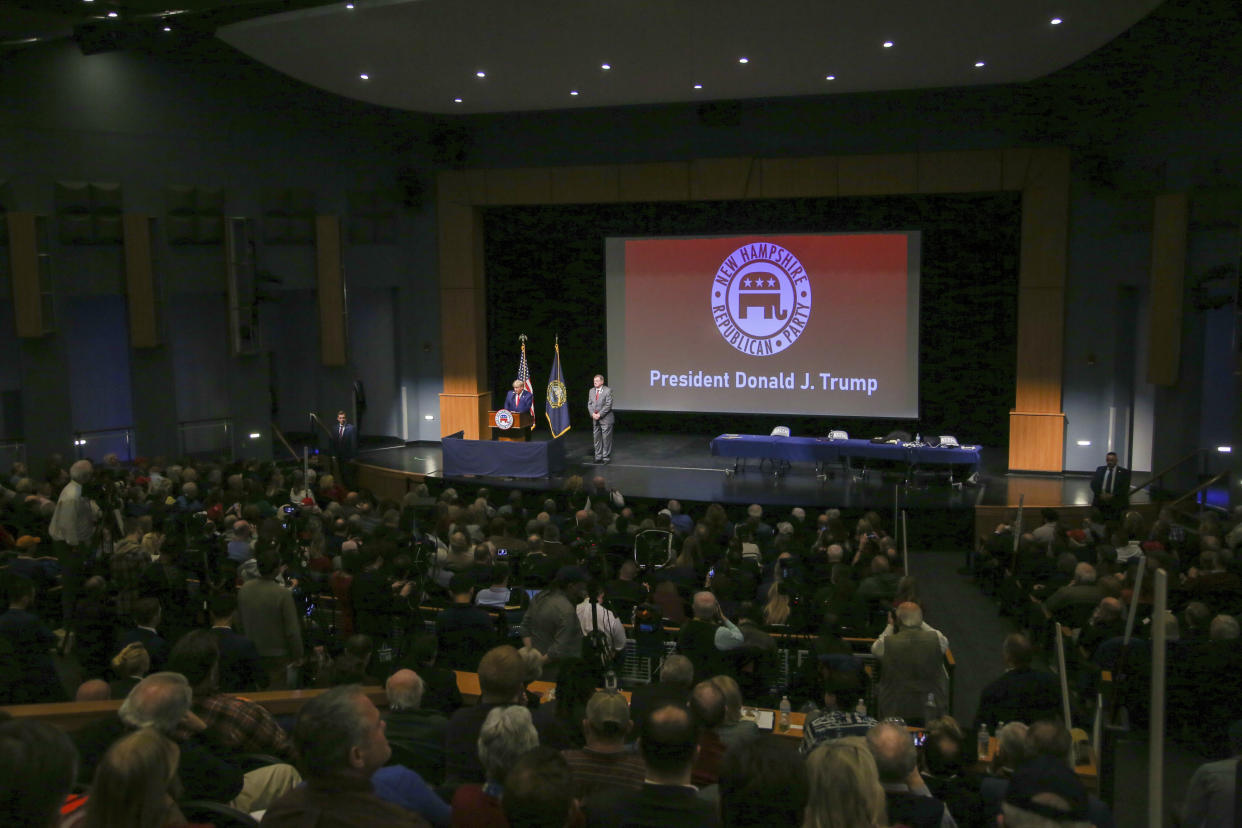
[358,431,1146,510]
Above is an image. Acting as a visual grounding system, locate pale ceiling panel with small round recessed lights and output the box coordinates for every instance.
[0,0,1161,114]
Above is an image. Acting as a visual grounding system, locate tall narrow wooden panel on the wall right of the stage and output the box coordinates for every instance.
[1148,192,1190,385]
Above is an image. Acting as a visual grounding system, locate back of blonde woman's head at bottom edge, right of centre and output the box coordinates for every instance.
[802,736,888,828]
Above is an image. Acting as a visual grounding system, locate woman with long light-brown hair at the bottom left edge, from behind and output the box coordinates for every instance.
[84,727,186,828]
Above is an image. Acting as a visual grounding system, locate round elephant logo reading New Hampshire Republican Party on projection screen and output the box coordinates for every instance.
[712,242,811,356]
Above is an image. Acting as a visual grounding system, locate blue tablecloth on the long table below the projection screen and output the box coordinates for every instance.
[712,434,980,466]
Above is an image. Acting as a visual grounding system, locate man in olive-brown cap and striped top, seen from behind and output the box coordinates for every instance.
[561,690,645,799]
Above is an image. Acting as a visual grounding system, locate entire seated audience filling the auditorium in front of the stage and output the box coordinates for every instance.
[0,461,1242,828]
